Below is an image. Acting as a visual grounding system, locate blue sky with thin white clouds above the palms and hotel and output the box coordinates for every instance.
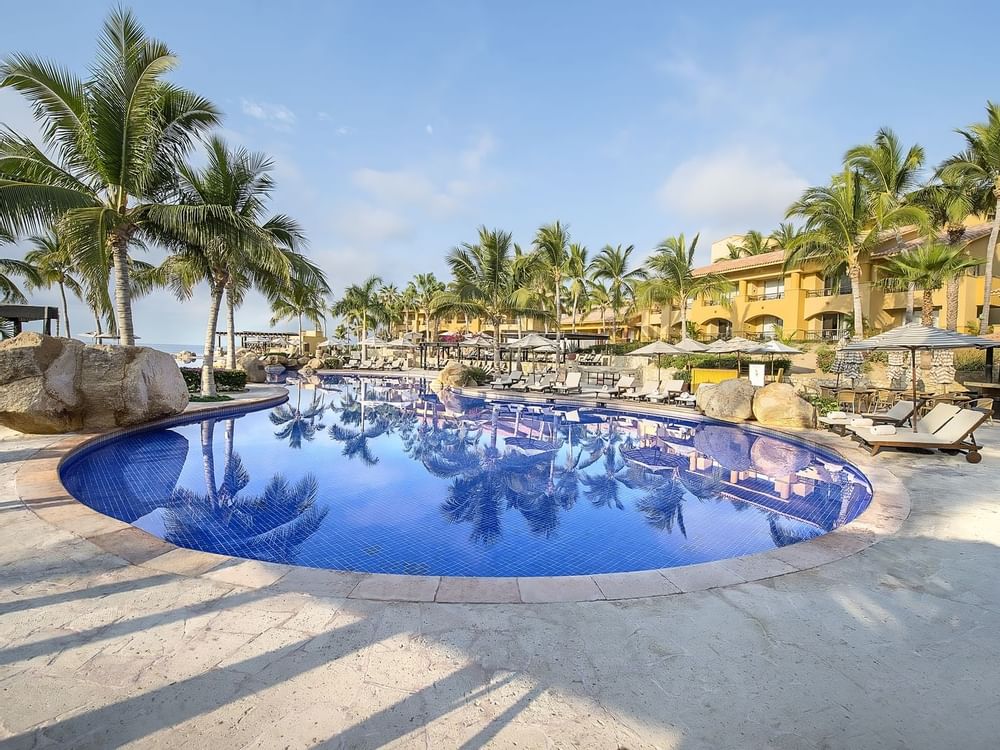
[0,0,1000,343]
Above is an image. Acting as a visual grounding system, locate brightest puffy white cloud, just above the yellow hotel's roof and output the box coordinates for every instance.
[656,147,808,239]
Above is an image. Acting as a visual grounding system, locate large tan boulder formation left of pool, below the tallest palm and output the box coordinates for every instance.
[0,333,188,434]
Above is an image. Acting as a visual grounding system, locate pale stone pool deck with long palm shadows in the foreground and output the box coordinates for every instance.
[0,390,1000,750]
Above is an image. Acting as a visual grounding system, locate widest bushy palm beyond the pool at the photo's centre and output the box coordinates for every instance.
[434,227,533,371]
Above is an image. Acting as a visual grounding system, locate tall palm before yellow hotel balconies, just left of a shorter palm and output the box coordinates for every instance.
[785,169,926,338]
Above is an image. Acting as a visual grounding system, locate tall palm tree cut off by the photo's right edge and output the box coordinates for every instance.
[940,102,1000,335]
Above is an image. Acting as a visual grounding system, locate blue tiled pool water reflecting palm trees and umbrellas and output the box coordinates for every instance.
[62,377,871,576]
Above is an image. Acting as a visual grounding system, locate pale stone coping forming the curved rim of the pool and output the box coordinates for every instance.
[15,387,910,604]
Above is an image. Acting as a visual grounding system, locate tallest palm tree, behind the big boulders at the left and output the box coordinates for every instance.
[0,8,219,346]
